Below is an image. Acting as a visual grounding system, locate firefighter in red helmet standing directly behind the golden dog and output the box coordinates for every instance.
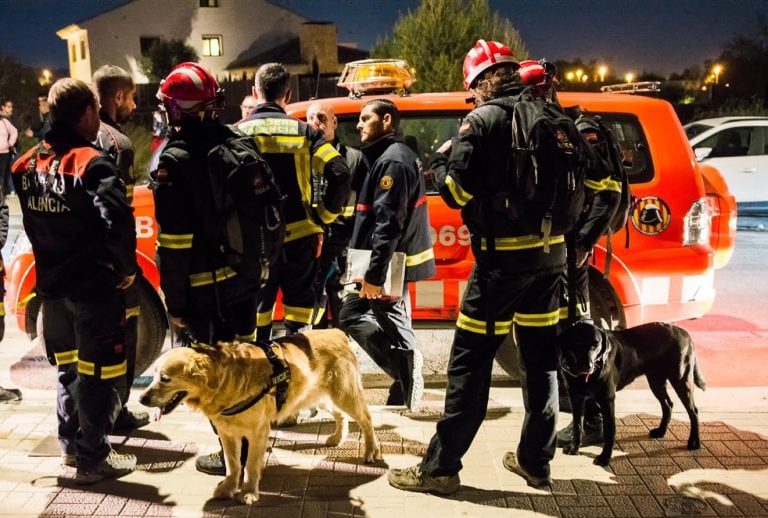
[150,63,259,475]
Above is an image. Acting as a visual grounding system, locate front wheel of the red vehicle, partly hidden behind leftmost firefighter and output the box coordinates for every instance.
[34,278,168,386]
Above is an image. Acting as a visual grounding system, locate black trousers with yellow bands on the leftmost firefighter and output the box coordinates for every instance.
[42,289,127,470]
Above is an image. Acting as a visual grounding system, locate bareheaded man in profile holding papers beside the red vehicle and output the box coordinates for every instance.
[340,99,436,410]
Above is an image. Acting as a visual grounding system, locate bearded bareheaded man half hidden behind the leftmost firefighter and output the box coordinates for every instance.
[92,65,149,431]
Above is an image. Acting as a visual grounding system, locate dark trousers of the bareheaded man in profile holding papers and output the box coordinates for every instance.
[339,283,416,388]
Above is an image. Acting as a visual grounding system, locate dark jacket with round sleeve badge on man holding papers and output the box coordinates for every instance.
[349,134,436,286]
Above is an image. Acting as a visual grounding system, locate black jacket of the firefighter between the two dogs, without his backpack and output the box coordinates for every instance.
[430,99,565,272]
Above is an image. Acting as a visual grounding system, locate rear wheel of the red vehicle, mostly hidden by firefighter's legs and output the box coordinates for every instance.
[496,269,626,379]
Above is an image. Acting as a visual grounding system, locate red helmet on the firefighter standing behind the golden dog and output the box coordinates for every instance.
[157,63,224,120]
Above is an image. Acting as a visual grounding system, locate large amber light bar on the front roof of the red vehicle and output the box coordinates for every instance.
[336,59,416,97]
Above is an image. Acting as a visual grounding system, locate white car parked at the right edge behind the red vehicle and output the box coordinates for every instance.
[690,117,768,215]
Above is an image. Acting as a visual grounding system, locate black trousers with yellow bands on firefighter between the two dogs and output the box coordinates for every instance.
[421,252,562,484]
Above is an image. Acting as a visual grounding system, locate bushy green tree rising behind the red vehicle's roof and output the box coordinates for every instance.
[371,0,528,92]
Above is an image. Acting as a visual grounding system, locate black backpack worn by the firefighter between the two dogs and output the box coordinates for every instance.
[486,89,591,252]
